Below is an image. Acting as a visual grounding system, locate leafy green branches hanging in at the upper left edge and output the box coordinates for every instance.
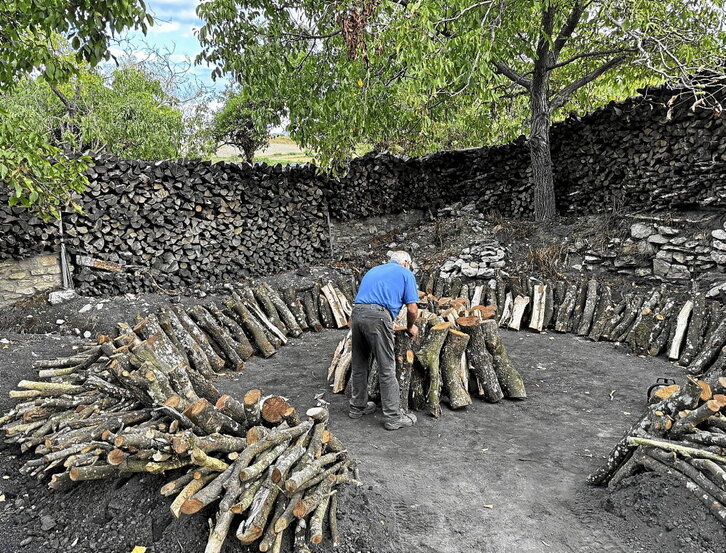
[0,0,153,218]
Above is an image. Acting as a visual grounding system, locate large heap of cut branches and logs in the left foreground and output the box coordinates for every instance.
[0,300,356,553]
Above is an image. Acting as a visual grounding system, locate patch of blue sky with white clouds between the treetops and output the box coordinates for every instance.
[115,0,226,92]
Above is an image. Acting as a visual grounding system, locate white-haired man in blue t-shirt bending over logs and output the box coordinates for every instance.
[348,251,418,430]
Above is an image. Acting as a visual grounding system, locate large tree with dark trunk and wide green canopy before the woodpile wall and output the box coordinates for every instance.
[197,0,724,220]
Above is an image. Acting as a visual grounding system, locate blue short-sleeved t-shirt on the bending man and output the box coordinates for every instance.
[355,261,418,319]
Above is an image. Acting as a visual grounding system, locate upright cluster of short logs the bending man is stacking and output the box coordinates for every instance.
[328,290,527,417]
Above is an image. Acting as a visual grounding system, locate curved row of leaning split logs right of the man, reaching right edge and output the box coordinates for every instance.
[412,271,726,375]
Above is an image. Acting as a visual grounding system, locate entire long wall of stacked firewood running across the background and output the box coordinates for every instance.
[0,80,726,294]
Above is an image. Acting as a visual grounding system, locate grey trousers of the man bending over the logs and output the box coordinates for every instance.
[350,305,401,422]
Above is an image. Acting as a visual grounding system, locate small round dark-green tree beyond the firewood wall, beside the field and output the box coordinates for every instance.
[211,89,282,163]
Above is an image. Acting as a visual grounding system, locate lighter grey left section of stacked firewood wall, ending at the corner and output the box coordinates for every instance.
[0,157,329,295]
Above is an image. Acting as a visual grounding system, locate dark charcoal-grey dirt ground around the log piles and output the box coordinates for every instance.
[0,322,726,553]
